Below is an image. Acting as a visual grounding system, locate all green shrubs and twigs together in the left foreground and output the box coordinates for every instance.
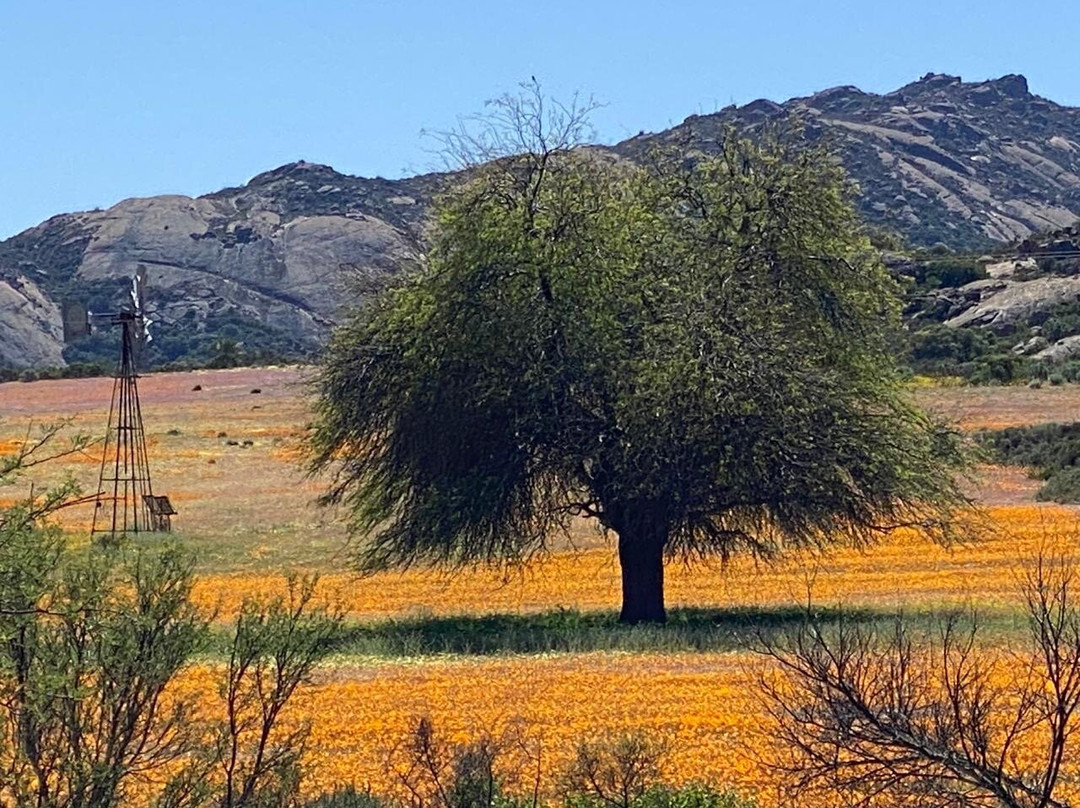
[0,425,340,808]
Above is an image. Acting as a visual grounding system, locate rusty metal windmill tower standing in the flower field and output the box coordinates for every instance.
[63,266,176,537]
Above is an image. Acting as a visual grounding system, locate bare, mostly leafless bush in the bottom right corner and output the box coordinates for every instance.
[760,555,1080,808]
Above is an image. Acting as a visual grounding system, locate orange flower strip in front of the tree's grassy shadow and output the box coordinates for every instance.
[172,652,762,794]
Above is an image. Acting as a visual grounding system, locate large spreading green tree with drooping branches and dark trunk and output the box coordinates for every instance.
[312,86,964,622]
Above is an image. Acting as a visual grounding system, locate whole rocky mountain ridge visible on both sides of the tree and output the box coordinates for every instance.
[0,75,1080,367]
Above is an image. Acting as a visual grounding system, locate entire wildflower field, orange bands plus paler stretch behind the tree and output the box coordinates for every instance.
[6,368,1080,802]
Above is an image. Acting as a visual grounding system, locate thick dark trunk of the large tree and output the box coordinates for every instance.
[619,517,667,623]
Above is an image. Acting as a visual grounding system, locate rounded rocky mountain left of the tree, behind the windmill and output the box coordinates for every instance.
[0,162,445,366]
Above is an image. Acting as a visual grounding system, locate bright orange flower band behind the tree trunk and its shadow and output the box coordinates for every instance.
[194,504,1080,620]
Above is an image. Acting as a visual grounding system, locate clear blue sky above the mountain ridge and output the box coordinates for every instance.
[0,0,1080,238]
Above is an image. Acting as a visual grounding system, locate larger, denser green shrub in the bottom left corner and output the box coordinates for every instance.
[0,527,205,808]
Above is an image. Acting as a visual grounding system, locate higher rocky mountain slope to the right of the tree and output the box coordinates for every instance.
[616,73,1080,250]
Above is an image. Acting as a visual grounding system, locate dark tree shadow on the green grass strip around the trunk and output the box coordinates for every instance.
[337,606,892,657]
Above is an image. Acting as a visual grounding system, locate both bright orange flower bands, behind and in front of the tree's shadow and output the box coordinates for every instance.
[172,506,1077,804]
